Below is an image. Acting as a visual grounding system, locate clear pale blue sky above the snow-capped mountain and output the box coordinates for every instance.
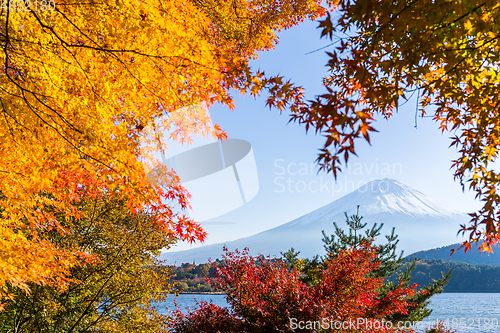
[164,18,481,251]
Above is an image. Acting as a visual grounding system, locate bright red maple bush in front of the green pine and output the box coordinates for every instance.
[173,242,422,332]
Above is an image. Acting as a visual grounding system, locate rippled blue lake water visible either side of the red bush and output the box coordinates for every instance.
[165,293,500,333]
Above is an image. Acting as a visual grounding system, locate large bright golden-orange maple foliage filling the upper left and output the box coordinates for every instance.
[0,0,325,299]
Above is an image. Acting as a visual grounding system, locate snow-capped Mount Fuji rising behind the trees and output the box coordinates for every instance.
[161,178,470,264]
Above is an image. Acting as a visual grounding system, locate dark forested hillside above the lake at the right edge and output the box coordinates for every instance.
[404,259,500,293]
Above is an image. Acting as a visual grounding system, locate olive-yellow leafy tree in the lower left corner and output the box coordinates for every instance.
[0,196,175,333]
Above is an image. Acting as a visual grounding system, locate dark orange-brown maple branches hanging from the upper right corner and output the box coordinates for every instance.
[286,0,500,251]
